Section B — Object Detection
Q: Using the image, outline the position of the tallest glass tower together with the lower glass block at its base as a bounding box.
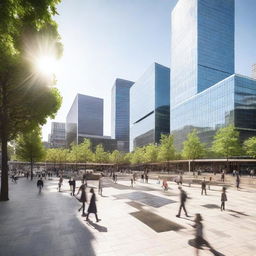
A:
[170,0,256,149]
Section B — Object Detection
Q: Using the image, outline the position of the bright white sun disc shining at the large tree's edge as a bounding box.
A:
[37,56,58,76]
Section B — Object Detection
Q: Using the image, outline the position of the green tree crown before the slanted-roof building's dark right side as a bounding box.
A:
[158,134,176,161]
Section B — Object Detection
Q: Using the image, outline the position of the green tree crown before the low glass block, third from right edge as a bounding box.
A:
[182,130,205,159]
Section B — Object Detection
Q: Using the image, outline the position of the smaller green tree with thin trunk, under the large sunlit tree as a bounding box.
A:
[16,127,46,180]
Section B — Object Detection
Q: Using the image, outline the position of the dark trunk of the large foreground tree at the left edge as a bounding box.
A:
[0,133,9,201]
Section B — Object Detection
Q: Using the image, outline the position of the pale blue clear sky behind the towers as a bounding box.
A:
[43,0,256,140]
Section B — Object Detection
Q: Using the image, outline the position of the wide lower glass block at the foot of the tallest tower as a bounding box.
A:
[171,75,256,149]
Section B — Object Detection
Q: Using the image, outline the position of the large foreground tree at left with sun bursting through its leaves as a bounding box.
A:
[0,0,62,201]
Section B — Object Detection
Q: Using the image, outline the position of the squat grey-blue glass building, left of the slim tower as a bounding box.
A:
[66,94,103,145]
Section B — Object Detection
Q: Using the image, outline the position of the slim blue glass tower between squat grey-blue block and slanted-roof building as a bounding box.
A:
[111,78,134,152]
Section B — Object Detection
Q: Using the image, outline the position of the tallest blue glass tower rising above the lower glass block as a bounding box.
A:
[171,0,234,107]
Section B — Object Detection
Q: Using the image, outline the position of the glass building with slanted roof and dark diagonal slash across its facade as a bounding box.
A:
[130,63,170,151]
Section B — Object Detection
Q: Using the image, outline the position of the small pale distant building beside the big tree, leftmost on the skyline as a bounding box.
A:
[48,122,66,148]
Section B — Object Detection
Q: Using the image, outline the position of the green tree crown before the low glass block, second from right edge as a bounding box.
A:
[212,125,242,158]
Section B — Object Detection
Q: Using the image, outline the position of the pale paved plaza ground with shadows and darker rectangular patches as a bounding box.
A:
[0,175,256,256]
